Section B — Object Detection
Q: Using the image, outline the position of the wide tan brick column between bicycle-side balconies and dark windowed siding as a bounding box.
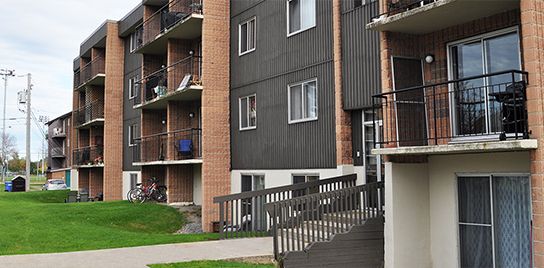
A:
[202,0,230,232]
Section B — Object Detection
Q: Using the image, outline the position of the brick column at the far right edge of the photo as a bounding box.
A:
[520,0,544,268]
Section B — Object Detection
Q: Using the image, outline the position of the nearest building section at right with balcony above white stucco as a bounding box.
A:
[366,0,544,267]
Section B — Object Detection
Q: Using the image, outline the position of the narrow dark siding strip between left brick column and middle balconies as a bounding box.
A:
[123,34,142,171]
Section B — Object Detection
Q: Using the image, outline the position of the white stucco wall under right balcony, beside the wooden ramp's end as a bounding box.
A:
[385,163,431,268]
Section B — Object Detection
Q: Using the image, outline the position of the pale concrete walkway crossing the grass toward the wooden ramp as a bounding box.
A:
[0,237,273,268]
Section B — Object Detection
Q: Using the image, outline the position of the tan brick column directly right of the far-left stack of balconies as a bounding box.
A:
[104,22,125,201]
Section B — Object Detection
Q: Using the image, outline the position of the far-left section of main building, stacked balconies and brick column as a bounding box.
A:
[72,20,124,200]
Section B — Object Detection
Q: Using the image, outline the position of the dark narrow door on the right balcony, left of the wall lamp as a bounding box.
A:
[393,57,427,146]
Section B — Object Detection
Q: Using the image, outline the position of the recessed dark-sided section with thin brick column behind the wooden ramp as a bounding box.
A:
[230,0,381,196]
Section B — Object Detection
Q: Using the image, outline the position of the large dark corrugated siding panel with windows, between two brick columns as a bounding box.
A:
[231,0,336,169]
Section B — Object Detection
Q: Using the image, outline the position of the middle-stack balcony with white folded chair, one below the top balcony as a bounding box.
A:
[133,56,202,110]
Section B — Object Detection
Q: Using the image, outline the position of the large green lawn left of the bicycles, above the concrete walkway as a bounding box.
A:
[0,188,219,255]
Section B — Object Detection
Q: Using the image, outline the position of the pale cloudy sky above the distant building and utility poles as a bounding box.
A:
[0,0,141,160]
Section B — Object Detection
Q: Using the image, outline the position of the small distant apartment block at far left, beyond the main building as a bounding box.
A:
[46,112,72,187]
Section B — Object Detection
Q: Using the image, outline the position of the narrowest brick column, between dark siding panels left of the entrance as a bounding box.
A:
[332,0,353,166]
